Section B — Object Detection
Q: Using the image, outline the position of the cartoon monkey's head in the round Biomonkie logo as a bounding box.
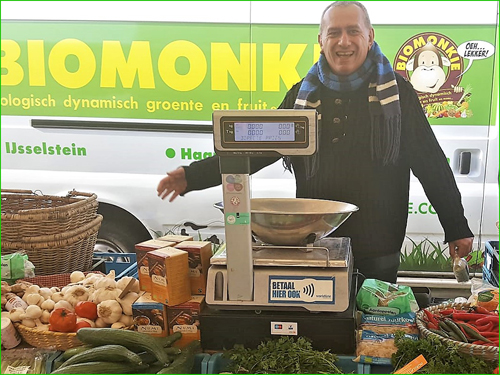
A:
[406,42,451,93]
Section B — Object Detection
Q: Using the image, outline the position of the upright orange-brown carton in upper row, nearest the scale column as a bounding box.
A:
[175,241,212,295]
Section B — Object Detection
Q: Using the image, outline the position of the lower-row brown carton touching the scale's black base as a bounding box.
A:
[167,296,205,348]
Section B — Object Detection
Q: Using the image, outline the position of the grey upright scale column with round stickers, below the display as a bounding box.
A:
[220,156,253,301]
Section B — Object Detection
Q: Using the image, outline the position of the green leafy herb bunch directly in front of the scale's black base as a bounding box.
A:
[224,336,343,374]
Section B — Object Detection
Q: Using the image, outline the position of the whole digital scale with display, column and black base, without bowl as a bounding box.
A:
[201,110,357,354]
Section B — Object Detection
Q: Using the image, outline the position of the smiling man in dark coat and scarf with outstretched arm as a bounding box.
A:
[157,1,473,283]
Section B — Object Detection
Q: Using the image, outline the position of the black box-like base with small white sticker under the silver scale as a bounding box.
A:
[200,276,358,355]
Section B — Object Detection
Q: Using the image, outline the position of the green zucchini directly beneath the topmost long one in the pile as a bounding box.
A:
[62,345,142,367]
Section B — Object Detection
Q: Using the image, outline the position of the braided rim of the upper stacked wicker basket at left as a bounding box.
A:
[1,189,97,221]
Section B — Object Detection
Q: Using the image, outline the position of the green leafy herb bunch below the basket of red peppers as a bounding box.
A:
[392,331,498,374]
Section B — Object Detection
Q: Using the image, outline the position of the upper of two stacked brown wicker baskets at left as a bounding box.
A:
[2,189,99,242]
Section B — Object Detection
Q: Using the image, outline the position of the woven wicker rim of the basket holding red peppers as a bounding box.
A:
[417,303,498,362]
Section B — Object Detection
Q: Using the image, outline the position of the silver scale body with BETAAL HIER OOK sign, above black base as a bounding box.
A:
[205,237,353,312]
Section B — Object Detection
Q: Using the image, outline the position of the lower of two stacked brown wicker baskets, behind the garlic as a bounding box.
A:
[2,215,103,275]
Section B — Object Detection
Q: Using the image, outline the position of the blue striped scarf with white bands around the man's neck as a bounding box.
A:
[294,42,401,179]
